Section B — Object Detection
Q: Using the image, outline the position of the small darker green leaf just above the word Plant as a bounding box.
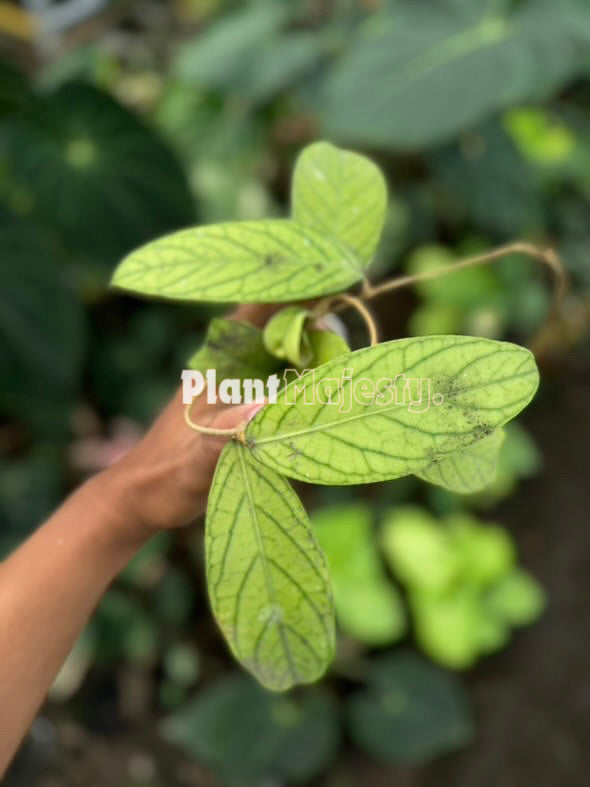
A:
[188,317,279,380]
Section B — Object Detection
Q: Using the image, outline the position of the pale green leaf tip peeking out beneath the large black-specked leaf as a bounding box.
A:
[416,429,505,495]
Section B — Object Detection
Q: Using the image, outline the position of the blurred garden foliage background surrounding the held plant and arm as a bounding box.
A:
[0,0,590,787]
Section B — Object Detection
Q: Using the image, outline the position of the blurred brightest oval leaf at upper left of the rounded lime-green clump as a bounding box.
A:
[381,506,461,592]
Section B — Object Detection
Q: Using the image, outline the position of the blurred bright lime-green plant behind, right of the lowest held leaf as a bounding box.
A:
[312,504,544,669]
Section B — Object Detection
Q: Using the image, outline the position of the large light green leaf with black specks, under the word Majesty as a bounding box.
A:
[247,336,539,485]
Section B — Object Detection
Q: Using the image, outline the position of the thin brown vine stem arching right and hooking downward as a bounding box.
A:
[361,241,568,315]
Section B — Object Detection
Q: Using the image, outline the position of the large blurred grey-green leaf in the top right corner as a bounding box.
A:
[317,0,590,150]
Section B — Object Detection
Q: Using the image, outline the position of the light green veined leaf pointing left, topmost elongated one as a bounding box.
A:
[113,219,361,303]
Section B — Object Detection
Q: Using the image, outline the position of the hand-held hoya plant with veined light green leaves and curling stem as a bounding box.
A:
[113,142,557,691]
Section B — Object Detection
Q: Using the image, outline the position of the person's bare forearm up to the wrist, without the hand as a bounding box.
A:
[0,471,148,776]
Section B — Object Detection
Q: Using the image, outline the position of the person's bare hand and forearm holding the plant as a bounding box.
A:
[0,306,271,777]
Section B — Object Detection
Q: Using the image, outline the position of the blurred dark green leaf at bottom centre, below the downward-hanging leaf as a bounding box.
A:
[163,675,340,787]
